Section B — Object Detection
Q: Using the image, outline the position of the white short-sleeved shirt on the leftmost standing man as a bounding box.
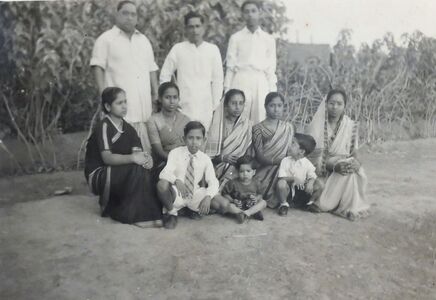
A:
[90,26,158,123]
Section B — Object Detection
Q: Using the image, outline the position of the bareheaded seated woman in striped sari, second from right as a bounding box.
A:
[253,92,294,208]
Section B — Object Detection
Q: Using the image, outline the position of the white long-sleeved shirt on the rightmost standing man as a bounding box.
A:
[224,27,277,91]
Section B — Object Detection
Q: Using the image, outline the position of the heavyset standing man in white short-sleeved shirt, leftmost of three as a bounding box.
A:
[90,0,158,150]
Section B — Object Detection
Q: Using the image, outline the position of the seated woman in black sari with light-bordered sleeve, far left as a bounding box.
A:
[85,87,162,224]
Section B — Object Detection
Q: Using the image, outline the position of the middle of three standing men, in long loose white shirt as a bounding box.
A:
[160,12,224,130]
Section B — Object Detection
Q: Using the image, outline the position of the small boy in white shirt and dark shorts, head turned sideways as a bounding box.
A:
[276,133,322,216]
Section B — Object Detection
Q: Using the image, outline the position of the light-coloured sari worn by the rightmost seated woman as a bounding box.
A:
[307,101,369,217]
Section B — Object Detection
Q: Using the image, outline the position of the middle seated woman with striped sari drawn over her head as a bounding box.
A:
[206,89,253,186]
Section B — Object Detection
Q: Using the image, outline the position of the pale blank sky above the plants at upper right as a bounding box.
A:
[282,0,436,47]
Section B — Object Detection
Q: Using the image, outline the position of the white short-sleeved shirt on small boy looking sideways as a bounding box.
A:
[278,156,317,185]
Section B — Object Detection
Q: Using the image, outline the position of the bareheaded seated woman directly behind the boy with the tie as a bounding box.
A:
[147,82,189,170]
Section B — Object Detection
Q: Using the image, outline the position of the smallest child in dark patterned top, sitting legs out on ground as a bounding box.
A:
[220,156,266,224]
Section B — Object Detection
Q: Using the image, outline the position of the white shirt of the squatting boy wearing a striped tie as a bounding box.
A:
[159,146,219,197]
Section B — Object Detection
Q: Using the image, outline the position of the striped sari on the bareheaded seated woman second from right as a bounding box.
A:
[253,121,294,208]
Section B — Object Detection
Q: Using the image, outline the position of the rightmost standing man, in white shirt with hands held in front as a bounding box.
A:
[224,0,277,124]
